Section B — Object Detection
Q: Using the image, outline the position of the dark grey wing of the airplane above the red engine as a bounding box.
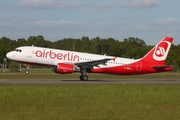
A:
[75,58,115,68]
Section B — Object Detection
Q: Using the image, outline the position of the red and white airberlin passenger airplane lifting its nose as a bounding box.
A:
[6,37,173,81]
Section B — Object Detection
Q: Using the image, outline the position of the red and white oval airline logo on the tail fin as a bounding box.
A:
[153,41,171,61]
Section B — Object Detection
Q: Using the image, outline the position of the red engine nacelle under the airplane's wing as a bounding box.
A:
[55,63,75,74]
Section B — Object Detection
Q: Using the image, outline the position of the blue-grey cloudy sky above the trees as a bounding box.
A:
[0,0,180,45]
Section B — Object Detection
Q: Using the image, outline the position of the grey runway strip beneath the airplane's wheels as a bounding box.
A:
[0,79,180,84]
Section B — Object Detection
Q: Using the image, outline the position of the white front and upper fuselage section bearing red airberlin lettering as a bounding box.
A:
[6,46,138,68]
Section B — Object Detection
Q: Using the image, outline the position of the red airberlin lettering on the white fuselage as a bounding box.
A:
[35,49,79,62]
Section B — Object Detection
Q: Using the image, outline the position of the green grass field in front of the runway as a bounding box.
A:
[0,84,180,120]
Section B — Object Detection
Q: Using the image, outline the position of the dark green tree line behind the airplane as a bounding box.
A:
[0,35,180,71]
